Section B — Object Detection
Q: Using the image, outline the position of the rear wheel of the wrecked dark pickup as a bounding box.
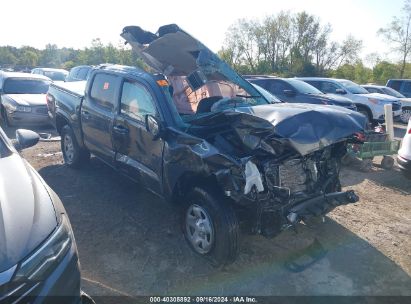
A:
[61,125,90,168]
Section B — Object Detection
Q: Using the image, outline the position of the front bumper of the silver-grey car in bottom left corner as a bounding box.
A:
[0,244,81,304]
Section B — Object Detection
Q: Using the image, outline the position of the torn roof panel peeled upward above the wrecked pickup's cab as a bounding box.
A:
[121,24,259,95]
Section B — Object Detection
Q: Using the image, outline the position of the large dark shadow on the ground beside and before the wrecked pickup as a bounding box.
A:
[40,158,411,302]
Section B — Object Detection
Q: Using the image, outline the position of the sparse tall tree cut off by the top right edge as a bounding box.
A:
[377,0,411,78]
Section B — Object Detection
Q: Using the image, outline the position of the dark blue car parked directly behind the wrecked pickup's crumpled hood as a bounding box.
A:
[244,75,357,111]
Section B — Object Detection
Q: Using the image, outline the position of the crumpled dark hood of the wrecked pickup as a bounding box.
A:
[190,103,365,155]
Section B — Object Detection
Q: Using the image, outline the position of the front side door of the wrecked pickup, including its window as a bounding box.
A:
[113,79,164,193]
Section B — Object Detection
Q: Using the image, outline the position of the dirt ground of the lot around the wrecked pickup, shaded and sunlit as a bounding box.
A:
[9,123,411,296]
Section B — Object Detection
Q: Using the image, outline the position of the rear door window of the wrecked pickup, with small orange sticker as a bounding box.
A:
[90,73,118,109]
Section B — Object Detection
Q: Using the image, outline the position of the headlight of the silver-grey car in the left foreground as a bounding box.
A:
[13,214,73,282]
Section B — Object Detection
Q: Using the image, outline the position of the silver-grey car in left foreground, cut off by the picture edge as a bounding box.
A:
[0,128,92,303]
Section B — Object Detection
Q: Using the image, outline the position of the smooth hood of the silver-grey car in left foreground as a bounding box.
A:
[0,154,57,273]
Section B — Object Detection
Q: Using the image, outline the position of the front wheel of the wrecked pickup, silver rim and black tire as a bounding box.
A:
[181,187,240,267]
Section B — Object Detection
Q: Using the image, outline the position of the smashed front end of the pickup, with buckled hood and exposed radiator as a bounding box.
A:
[185,106,363,236]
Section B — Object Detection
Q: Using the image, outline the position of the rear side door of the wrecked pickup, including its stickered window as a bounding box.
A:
[80,71,121,163]
